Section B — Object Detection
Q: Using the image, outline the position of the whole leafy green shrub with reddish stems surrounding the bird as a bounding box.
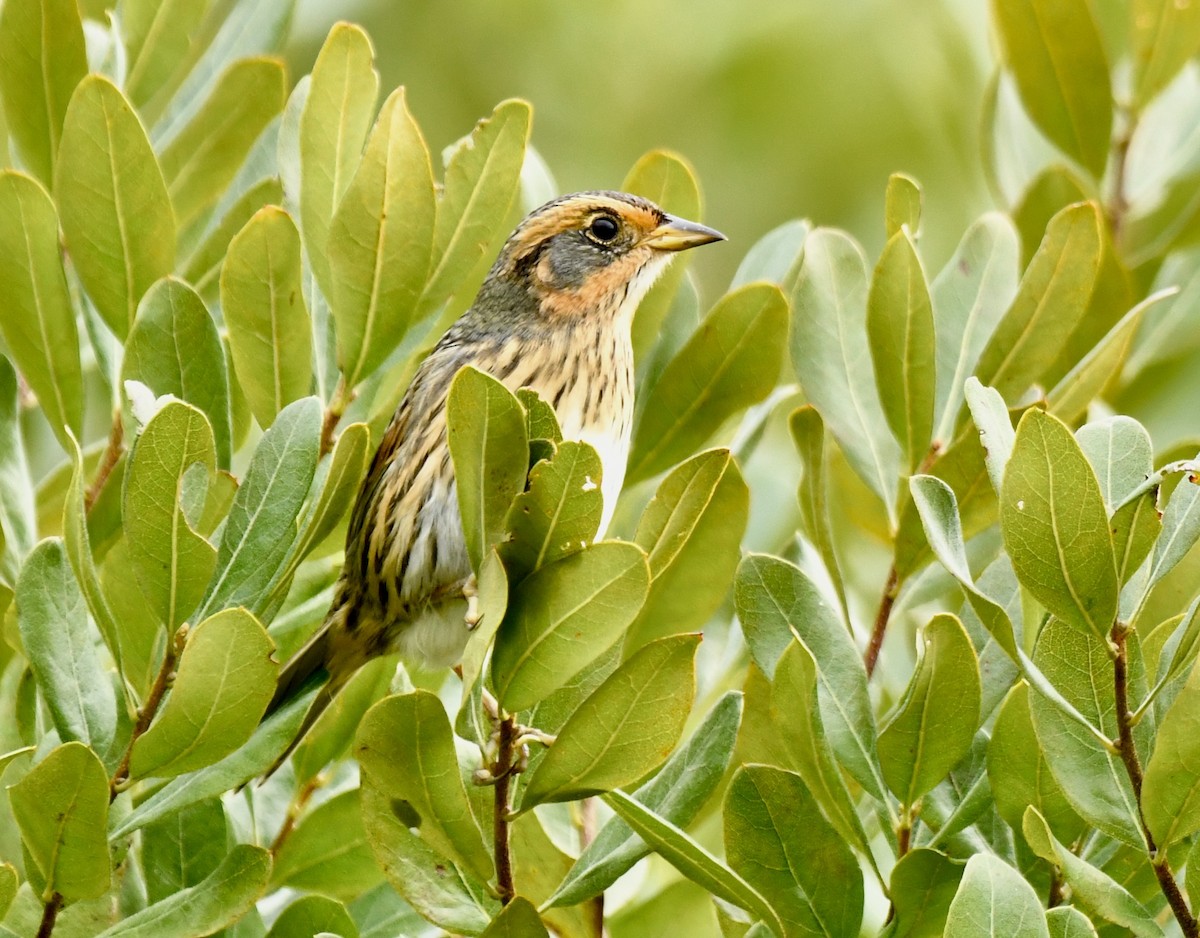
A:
[0,0,1200,938]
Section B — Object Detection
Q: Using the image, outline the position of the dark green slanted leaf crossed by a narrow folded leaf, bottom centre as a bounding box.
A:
[546,691,742,906]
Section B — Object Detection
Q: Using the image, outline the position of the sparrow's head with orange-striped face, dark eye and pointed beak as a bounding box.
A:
[480,192,725,321]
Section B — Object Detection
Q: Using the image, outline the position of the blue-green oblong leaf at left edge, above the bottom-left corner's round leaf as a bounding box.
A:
[17,537,116,753]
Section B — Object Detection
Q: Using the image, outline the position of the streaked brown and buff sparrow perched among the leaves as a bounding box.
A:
[266,190,725,771]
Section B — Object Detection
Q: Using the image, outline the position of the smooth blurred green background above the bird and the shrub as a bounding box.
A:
[288,0,992,297]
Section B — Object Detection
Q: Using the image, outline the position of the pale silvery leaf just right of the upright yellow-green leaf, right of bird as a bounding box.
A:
[930,212,1020,440]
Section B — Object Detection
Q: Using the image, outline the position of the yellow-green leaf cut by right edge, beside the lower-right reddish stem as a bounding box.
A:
[1141,667,1200,850]
